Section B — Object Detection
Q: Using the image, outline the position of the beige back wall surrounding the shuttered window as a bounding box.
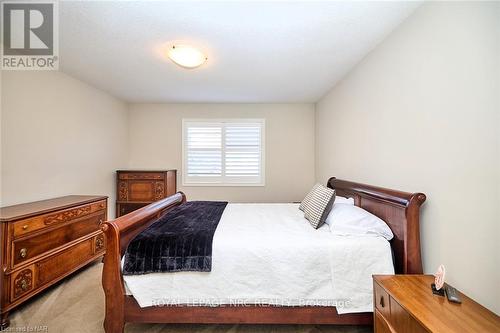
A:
[129,104,315,202]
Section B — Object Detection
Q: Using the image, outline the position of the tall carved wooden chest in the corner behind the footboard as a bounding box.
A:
[116,170,177,217]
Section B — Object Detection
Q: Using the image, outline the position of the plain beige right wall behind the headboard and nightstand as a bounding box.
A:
[316,2,500,313]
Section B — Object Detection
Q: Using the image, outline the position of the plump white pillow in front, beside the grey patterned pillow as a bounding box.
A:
[325,203,394,240]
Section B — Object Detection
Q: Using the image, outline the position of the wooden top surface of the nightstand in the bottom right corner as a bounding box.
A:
[374,275,500,333]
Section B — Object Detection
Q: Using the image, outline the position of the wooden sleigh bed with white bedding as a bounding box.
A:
[103,178,425,332]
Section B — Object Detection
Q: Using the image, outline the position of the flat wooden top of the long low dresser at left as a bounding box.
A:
[0,195,108,222]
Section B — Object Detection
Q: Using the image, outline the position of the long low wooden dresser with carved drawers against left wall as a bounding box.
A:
[0,195,107,329]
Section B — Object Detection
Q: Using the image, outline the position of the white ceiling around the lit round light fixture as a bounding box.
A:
[59,1,420,103]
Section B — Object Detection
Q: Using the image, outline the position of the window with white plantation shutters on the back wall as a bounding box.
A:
[182,119,265,186]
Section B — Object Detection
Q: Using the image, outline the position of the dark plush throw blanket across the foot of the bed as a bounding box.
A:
[123,201,227,275]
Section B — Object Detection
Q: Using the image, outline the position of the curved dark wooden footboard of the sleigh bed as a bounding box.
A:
[102,192,186,333]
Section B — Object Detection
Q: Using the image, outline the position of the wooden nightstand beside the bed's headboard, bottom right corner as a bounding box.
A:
[373,275,500,333]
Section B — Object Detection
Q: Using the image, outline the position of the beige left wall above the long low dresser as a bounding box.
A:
[1,71,128,216]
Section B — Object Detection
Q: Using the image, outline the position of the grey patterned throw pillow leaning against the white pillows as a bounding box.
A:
[304,185,335,229]
